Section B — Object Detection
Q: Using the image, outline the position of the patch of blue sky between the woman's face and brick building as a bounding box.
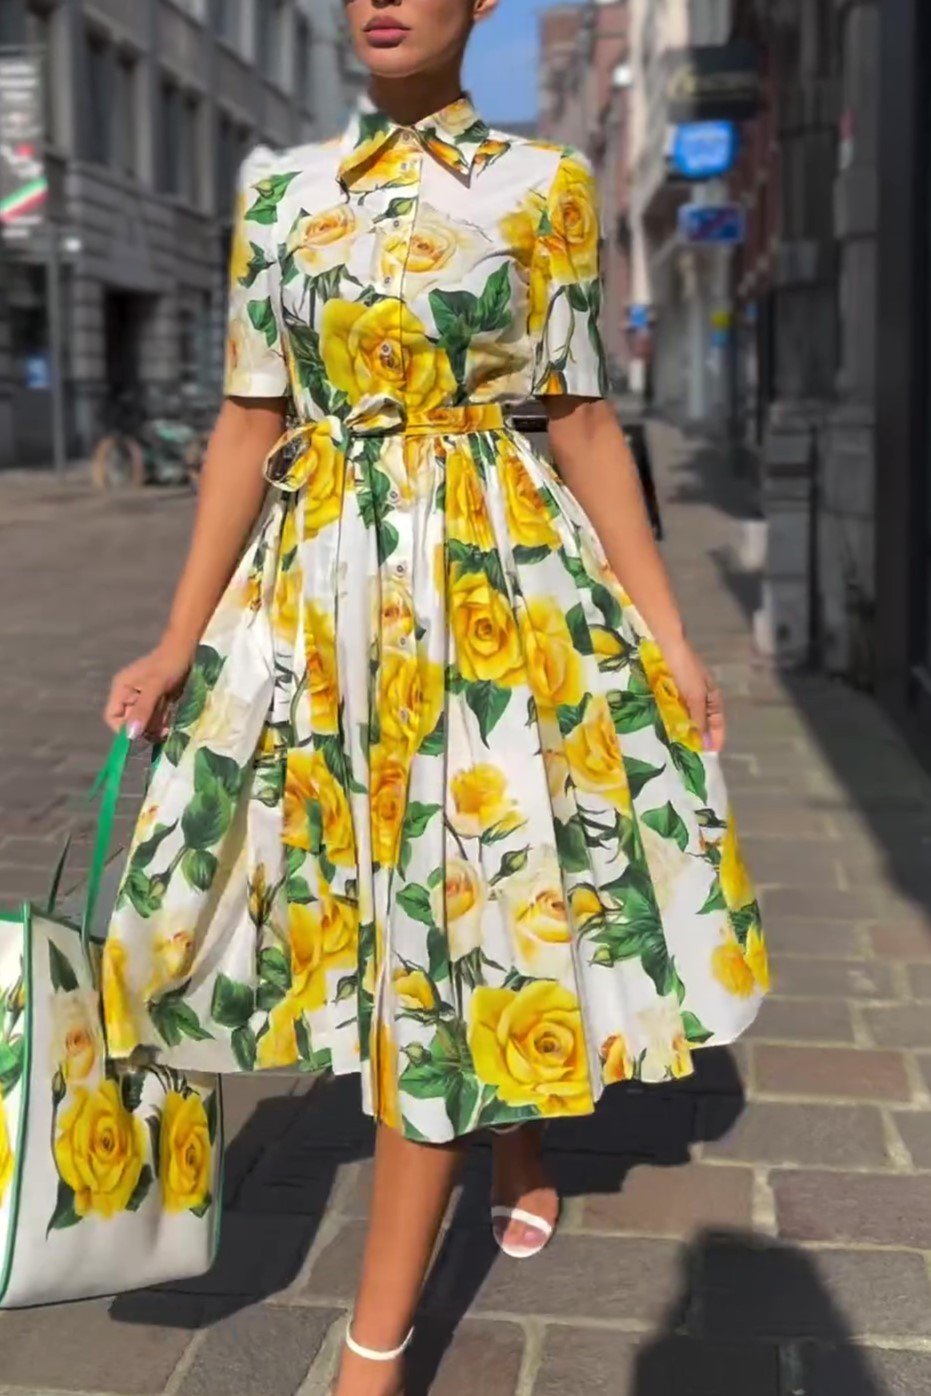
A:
[466,0,575,123]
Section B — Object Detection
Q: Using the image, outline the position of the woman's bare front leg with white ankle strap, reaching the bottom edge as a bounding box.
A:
[335,1125,462,1396]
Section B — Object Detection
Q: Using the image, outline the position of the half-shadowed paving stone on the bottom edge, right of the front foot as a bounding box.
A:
[533,1326,780,1396]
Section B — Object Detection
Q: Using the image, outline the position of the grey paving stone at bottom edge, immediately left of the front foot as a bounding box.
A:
[177,1304,341,1396]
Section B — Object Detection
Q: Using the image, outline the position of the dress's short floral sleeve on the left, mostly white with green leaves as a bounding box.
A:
[223,147,290,398]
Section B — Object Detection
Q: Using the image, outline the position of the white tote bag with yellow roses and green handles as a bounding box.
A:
[0,734,222,1308]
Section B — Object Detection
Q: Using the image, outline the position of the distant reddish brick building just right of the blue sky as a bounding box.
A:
[540,0,631,384]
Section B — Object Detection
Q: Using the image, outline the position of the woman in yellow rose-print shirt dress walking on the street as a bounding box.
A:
[105,0,766,1396]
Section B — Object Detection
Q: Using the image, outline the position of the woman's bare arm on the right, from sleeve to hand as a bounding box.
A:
[543,395,724,751]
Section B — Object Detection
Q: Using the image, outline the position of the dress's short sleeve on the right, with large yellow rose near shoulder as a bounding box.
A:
[530,151,607,398]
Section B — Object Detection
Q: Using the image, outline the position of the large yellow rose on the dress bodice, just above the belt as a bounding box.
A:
[321,299,456,412]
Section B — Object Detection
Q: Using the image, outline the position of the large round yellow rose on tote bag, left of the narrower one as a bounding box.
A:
[54,1081,147,1217]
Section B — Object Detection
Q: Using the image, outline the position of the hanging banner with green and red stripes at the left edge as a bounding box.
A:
[0,53,49,242]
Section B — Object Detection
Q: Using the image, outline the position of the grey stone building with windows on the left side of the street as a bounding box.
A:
[0,0,359,465]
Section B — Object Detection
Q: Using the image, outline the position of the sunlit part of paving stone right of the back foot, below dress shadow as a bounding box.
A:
[582,1163,754,1237]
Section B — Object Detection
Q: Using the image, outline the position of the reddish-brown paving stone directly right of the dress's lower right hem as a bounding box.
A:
[754,1043,911,1100]
